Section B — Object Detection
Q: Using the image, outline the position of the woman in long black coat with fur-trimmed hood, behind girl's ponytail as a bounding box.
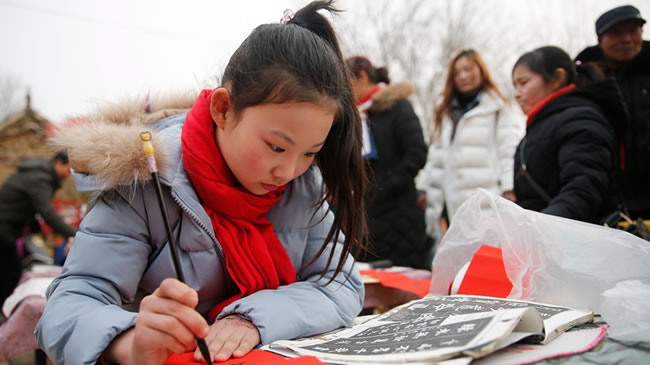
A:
[346,56,432,270]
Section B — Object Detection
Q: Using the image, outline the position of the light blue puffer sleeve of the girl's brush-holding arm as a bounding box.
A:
[35,189,151,364]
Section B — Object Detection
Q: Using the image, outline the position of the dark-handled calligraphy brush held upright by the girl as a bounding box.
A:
[140,132,212,364]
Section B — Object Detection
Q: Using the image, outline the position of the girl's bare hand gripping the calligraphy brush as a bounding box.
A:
[125,279,210,365]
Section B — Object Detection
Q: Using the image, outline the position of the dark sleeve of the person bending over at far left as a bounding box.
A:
[25,178,75,238]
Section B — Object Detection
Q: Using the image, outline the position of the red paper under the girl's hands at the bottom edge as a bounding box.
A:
[165,350,324,365]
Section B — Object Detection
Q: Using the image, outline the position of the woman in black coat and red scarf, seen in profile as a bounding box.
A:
[512,47,624,223]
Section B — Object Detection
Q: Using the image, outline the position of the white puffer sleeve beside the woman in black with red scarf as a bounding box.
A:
[496,104,526,193]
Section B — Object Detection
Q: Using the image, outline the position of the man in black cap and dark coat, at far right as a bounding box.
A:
[576,5,650,219]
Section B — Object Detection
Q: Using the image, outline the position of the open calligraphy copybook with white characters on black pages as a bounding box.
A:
[266,295,593,364]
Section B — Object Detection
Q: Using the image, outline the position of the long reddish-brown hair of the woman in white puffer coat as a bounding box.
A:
[430,49,510,142]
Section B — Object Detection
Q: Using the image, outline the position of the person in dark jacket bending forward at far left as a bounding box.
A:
[0,152,75,303]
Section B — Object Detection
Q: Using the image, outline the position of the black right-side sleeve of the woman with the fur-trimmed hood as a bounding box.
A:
[387,99,427,190]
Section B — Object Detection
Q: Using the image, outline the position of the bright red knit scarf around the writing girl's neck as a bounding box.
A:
[181,90,296,321]
